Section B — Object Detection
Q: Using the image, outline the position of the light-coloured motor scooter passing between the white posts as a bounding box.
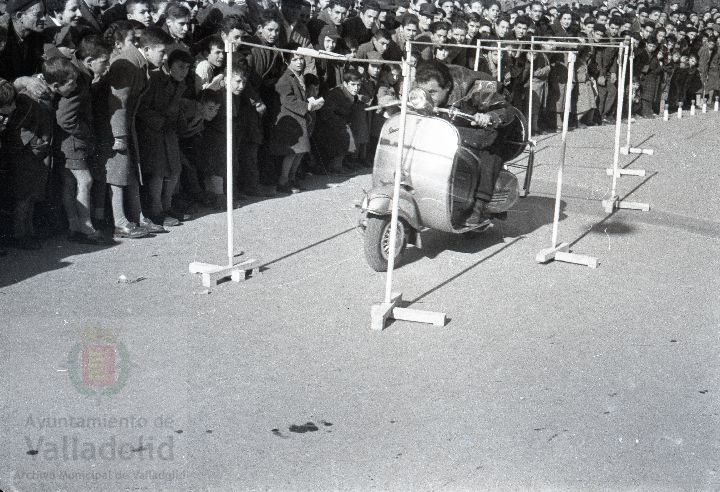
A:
[359,91,529,272]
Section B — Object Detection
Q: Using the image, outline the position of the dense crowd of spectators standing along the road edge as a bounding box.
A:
[0,0,720,249]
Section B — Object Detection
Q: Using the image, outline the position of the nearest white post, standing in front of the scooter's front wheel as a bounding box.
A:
[370,41,447,330]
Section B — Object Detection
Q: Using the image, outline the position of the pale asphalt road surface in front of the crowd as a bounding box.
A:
[0,112,720,492]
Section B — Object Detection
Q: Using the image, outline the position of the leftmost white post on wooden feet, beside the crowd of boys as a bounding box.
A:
[189,41,260,287]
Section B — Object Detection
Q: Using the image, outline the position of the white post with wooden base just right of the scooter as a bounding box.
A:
[535,53,598,268]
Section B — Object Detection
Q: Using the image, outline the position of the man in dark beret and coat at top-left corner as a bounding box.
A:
[0,0,49,100]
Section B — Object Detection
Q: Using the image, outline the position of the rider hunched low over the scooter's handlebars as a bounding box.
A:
[415,60,514,226]
